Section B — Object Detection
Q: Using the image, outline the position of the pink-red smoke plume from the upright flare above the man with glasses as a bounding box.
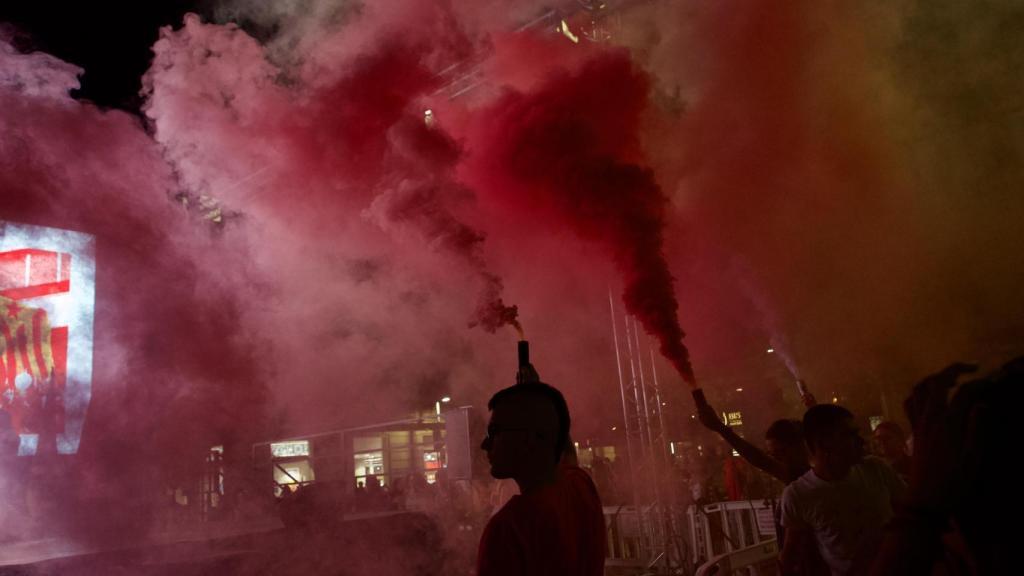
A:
[146,16,516,332]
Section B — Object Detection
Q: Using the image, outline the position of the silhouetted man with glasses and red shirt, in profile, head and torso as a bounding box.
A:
[477,382,605,576]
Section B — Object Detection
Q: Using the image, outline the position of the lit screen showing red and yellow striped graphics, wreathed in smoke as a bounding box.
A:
[0,220,96,456]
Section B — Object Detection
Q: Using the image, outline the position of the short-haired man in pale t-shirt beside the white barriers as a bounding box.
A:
[780,404,906,576]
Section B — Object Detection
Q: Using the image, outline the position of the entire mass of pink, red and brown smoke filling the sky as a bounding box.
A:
[0,0,1024,573]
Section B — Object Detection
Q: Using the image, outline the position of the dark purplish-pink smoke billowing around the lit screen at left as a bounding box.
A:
[0,33,266,538]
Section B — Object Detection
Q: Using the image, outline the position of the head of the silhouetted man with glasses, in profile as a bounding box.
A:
[480,382,570,494]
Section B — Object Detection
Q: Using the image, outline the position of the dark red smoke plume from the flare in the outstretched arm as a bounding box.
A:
[467,47,695,384]
